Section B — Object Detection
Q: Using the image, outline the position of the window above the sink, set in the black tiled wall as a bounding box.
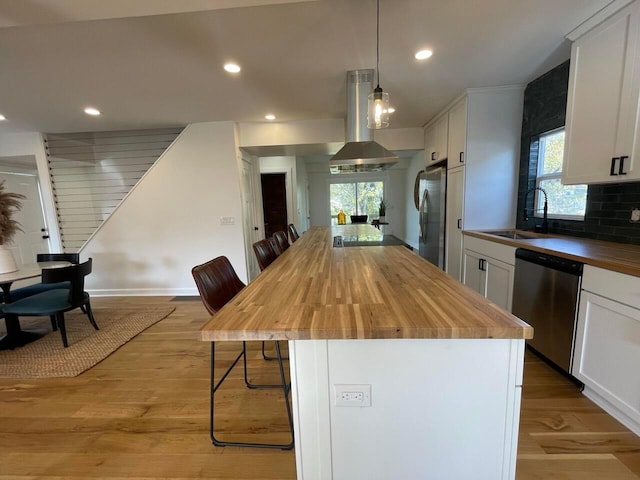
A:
[531,128,587,220]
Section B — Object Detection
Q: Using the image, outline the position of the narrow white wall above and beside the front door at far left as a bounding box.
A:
[0,132,62,252]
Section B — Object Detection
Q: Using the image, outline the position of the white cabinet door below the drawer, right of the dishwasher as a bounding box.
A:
[571,290,640,432]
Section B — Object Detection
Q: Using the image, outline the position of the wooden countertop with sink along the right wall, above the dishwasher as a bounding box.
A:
[464,231,640,277]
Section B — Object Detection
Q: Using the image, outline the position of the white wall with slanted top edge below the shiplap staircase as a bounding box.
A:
[81,122,247,295]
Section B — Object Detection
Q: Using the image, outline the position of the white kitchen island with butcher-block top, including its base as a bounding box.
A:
[202,225,533,480]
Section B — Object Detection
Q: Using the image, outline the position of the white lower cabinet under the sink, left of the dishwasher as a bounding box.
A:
[462,236,515,311]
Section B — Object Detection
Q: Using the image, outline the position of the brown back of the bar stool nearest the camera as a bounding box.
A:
[191,257,245,315]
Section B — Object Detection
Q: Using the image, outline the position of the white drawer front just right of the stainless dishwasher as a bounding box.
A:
[582,265,640,308]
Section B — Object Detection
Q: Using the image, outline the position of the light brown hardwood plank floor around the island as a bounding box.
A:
[0,297,640,480]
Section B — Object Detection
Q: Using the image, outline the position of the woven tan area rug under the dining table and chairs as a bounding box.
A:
[0,307,175,378]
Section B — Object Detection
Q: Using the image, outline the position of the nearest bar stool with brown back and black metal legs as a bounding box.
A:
[191,257,294,450]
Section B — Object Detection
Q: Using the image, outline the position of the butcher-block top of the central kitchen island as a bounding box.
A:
[201,224,533,341]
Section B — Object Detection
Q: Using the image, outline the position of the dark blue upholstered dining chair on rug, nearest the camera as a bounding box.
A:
[2,259,99,348]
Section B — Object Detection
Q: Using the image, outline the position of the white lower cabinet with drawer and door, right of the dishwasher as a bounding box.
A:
[572,265,640,435]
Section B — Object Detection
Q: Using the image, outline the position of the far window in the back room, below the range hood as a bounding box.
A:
[329,182,384,225]
